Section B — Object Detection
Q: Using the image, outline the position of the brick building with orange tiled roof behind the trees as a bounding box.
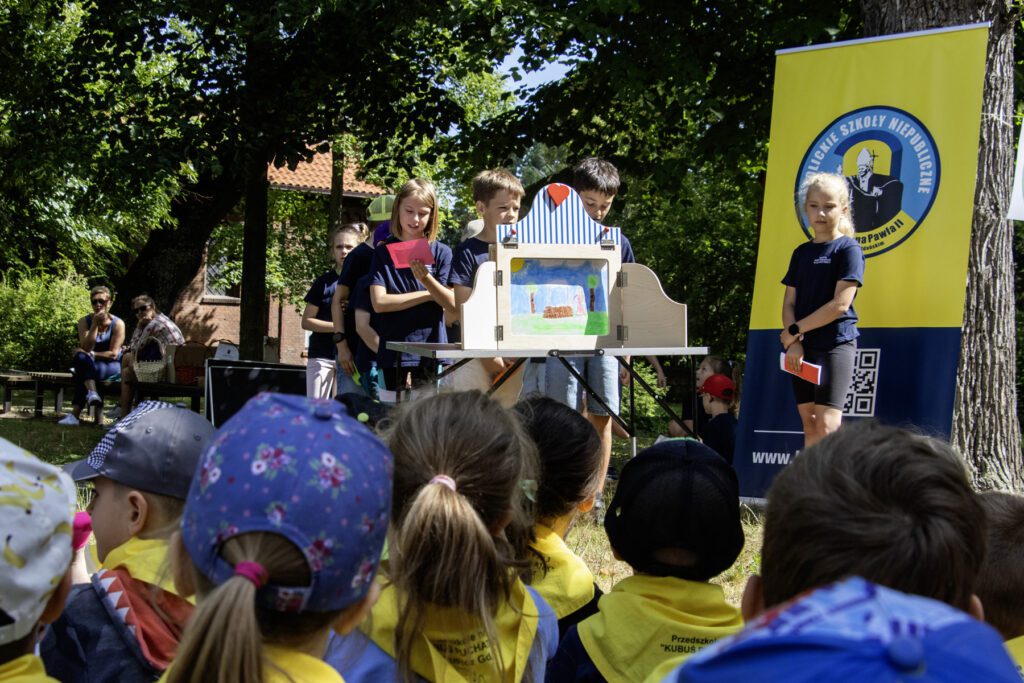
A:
[171,154,388,365]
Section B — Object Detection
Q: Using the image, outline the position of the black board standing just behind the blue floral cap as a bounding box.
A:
[206,358,306,427]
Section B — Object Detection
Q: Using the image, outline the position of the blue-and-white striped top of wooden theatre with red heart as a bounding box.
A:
[498,183,621,245]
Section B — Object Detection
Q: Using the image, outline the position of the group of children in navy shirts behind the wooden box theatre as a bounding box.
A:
[303,158,704,465]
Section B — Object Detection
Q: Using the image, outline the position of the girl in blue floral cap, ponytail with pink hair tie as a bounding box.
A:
[161,394,392,683]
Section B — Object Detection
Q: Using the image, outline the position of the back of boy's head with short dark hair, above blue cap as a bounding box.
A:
[751,422,985,615]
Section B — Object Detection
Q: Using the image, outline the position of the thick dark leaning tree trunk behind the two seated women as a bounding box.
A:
[114,174,242,321]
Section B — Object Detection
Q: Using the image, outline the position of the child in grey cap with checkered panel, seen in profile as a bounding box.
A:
[40,401,216,683]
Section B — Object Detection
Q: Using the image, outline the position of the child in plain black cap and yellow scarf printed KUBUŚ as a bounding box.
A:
[547,439,743,682]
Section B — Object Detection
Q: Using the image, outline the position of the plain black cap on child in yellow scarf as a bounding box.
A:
[604,438,744,581]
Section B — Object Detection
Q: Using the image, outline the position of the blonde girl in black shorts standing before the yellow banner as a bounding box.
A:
[779,173,864,447]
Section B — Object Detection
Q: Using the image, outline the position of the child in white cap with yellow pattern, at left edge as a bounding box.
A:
[0,438,75,683]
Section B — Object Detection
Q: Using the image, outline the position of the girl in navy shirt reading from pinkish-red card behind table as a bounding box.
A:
[370,178,455,391]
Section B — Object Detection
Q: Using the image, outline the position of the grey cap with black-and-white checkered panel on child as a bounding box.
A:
[65,400,215,500]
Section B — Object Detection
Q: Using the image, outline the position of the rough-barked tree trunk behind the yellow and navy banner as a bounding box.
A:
[861,0,1024,490]
